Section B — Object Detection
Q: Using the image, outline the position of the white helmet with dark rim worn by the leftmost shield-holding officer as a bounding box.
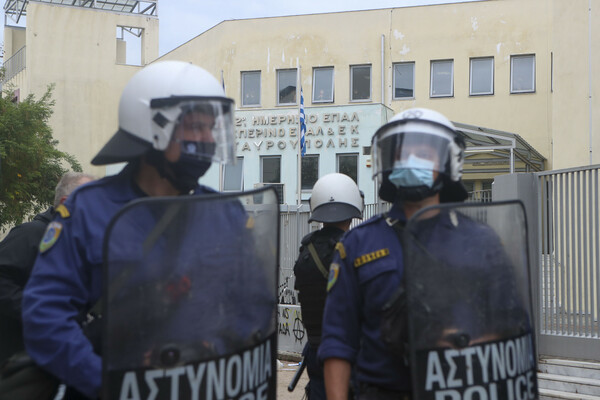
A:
[92,61,235,165]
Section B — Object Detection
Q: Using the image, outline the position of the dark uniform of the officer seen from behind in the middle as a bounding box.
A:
[294,226,344,399]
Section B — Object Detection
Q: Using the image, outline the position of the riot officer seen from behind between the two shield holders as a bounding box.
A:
[294,173,363,400]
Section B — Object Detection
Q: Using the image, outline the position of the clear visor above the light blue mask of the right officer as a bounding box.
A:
[373,127,451,180]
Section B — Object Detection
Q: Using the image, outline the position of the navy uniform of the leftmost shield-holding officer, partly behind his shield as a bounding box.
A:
[23,166,274,398]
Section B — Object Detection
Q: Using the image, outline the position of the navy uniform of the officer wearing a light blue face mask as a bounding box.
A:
[319,203,518,399]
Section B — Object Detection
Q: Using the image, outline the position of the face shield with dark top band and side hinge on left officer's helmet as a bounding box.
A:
[151,98,235,164]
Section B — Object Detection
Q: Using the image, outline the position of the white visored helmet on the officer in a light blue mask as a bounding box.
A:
[372,108,467,201]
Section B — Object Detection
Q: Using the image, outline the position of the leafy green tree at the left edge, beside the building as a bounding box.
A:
[0,85,81,226]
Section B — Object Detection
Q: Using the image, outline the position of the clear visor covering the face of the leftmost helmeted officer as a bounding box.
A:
[171,98,235,163]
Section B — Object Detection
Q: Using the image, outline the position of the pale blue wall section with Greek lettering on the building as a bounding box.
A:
[232,103,392,204]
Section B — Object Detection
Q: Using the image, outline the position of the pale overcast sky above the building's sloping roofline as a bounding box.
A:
[0,0,481,59]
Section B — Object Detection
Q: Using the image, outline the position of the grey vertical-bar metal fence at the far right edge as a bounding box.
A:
[536,166,600,360]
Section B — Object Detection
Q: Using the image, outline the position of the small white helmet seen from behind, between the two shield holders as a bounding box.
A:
[308,173,364,222]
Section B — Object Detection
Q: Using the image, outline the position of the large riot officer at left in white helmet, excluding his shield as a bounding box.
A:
[23,61,239,398]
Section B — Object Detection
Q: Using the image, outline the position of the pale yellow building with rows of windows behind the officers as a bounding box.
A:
[4,0,600,204]
